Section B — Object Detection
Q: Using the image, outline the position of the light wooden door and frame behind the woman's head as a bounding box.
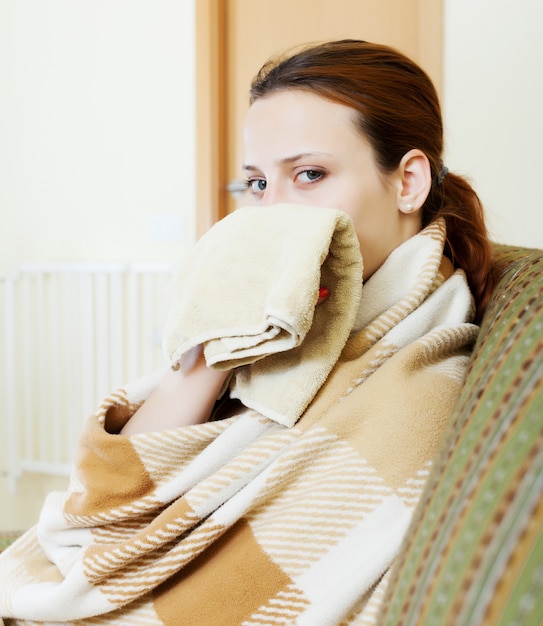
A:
[195,0,442,235]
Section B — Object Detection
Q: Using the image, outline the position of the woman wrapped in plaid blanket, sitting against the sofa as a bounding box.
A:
[0,40,493,626]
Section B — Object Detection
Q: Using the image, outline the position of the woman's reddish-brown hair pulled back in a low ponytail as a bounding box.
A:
[250,39,495,320]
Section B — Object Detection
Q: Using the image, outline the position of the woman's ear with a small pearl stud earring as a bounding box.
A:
[398,148,432,214]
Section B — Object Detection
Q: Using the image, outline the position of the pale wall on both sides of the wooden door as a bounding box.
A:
[0,0,543,274]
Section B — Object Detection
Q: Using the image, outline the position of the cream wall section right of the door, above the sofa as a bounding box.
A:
[443,0,543,248]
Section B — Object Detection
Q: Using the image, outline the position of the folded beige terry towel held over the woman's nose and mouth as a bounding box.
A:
[164,204,362,426]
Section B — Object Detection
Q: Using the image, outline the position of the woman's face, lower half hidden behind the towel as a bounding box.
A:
[243,90,420,279]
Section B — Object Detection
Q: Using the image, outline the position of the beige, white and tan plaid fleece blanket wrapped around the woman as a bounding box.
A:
[0,207,477,626]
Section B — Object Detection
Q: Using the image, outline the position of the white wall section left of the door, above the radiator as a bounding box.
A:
[0,0,195,275]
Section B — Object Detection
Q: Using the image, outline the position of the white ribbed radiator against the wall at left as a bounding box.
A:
[5,264,173,488]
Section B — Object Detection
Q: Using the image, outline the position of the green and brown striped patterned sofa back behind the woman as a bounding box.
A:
[380,246,543,626]
